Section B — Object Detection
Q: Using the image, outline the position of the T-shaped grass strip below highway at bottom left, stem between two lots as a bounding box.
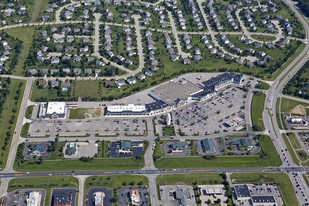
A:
[8,177,78,206]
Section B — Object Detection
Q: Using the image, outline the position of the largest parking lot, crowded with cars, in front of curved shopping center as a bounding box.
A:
[172,85,250,135]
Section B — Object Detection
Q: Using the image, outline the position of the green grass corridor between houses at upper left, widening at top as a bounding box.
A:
[5,26,34,76]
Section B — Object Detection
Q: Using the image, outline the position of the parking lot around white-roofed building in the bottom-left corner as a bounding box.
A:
[2,189,45,206]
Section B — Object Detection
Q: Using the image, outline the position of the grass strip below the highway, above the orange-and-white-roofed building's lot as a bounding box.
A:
[85,175,148,190]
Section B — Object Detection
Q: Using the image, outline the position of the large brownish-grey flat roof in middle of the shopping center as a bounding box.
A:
[150,80,203,105]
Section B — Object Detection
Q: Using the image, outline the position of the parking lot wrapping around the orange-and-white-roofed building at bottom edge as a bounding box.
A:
[117,187,149,206]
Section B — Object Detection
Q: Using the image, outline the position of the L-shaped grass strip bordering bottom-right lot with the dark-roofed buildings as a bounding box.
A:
[231,173,299,206]
